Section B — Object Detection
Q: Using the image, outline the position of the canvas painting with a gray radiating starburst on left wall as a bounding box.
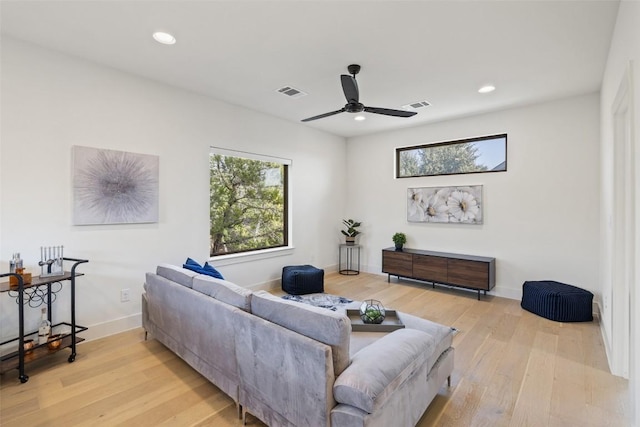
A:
[72,146,160,225]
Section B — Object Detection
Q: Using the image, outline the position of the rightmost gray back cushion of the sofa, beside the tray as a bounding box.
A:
[251,291,351,376]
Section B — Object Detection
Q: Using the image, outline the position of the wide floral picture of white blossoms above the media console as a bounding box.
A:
[407,185,482,224]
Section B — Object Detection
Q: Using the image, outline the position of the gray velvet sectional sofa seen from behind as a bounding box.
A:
[142,265,454,427]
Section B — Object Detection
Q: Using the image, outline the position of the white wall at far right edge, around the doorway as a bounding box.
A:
[600,1,640,426]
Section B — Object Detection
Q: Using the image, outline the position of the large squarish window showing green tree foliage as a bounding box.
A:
[209,148,291,256]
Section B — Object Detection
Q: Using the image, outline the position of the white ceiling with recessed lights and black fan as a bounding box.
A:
[0,0,618,137]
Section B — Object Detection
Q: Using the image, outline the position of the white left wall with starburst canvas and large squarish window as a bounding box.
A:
[0,37,346,338]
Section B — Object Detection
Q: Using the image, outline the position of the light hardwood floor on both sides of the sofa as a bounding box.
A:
[0,273,630,427]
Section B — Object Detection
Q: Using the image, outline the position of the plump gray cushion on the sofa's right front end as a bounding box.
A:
[333,329,435,414]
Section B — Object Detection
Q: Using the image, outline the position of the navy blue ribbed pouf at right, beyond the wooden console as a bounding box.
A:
[520,280,593,322]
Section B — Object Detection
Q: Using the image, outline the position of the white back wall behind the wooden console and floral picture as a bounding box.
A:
[347,94,600,299]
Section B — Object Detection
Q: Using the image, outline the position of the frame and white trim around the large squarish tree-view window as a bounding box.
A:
[208,146,293,265]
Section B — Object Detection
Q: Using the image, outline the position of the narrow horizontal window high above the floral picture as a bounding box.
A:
[396,134,507,178]
